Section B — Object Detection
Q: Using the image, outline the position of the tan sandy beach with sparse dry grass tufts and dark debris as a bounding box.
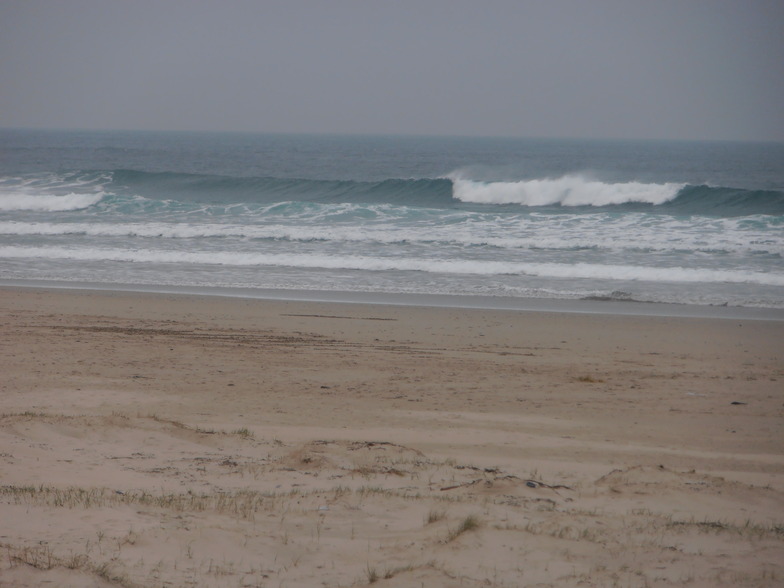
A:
[0,288,784,587]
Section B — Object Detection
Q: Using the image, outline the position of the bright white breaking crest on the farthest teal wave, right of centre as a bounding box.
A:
[450,175,685,206]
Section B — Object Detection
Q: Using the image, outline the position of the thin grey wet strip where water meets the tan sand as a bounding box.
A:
[0,279,784,321]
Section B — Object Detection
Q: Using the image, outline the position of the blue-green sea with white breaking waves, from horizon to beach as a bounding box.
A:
[0,129,784,309]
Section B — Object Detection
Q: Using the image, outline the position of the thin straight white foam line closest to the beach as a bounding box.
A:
[0,246,784,286]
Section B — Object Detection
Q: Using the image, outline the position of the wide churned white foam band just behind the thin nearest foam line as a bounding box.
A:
[0,213,784,255]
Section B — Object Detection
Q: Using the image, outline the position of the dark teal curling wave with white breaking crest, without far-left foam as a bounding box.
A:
[96,170,784,216]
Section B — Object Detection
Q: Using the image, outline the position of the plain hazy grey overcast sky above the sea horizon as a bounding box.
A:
[0,0,784,141]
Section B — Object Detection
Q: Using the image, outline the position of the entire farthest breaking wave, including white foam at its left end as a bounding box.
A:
[0,169,784,216]
